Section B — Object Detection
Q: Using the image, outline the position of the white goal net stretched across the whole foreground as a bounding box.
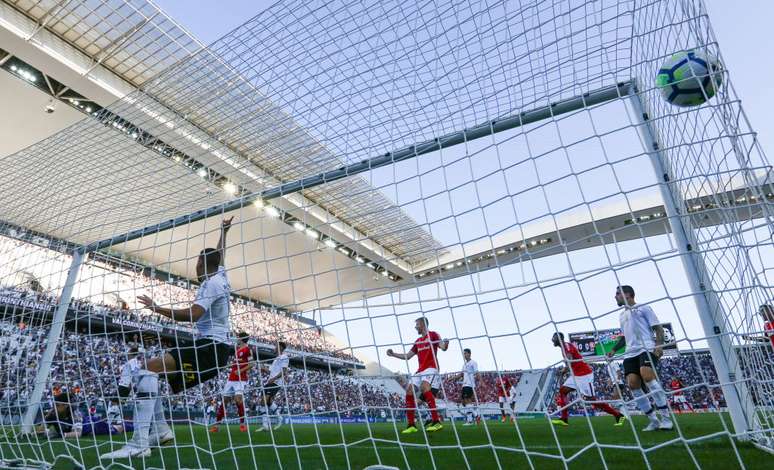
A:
[0,0,774,468]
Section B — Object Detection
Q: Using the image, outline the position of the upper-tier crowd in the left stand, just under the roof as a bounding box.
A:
[0,236,358,362]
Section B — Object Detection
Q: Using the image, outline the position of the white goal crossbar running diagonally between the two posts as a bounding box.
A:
[80,81,631,253]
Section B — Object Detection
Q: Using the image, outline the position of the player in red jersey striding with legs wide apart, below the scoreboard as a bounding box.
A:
[551,332,626,426]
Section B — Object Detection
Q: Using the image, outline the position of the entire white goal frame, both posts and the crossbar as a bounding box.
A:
[22,76,769,444]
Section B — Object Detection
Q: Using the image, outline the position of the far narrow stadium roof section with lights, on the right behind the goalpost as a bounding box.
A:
[415,170,774,283]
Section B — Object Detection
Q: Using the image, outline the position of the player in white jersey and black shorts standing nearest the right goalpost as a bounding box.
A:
[607,286,674,431]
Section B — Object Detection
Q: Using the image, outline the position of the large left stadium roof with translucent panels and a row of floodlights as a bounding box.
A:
[0,0,442,307]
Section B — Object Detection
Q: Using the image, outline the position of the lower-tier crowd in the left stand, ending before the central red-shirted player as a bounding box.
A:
[0,322,403,414]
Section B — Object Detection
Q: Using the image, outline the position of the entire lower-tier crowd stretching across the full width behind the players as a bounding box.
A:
[0,321,772,424]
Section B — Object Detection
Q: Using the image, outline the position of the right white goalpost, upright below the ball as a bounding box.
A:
[629,85,755,440]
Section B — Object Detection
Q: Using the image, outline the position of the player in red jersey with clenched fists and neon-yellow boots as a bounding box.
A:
[387,317,449,434]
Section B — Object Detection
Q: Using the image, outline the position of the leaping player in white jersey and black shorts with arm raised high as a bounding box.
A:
[100,217,234,459]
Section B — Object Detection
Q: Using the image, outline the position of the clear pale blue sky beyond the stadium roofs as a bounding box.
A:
[152,0,774,371]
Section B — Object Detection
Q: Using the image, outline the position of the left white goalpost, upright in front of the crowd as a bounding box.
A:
[21,250,84,434]
